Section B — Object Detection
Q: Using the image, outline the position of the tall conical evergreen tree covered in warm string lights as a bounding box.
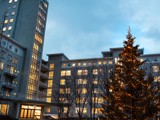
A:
[103,29,158,120]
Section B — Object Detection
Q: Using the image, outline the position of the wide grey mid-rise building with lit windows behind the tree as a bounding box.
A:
[47,48,160,118]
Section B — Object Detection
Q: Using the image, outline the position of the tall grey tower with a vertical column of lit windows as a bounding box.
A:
[0,0,48,99]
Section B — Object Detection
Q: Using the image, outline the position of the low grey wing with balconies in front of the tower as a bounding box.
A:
[0,33,26,118]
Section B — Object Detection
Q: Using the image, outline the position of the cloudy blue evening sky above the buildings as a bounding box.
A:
[43,0,160,60]
